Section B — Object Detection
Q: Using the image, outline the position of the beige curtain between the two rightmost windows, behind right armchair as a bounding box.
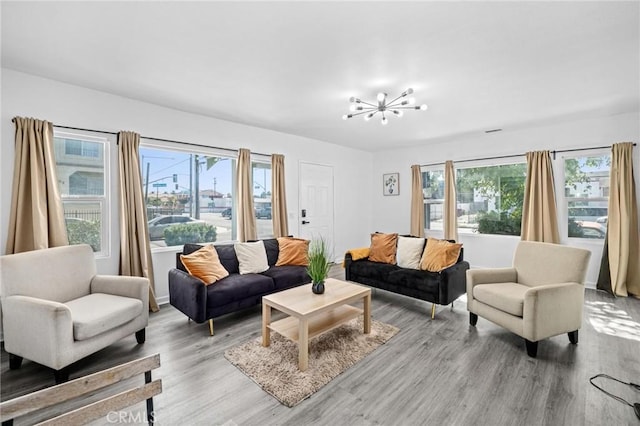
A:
[520,151,560,244]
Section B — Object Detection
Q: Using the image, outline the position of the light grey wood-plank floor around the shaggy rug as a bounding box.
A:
[0,266,640,426]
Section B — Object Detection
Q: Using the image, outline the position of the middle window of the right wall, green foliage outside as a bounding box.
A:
[456,163,527,235]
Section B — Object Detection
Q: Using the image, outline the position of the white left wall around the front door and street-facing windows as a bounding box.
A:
[0,69,373,302]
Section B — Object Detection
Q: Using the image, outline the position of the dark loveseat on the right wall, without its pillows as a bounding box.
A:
[344,241,469,318]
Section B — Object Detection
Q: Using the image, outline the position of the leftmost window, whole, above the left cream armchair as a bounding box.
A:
[53,132,109,255]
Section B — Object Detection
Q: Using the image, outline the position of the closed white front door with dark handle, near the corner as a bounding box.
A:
[298,162,334,258]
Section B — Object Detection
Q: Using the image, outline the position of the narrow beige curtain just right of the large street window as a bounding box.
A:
[236,148,258,241]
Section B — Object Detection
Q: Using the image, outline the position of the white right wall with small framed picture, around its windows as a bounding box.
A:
[373,111,640,286]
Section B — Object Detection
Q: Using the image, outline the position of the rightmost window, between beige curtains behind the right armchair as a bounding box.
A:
[564,154,611,239]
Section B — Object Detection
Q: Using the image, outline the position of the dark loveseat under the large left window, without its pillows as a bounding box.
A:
[169,238,311,335]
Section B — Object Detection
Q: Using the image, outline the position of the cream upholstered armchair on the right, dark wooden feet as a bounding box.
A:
[467,241,591,358]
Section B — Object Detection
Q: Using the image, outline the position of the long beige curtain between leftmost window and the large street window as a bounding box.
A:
[118,132,159,312]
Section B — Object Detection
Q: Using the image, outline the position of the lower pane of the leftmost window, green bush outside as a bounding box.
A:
[62,201,102,252]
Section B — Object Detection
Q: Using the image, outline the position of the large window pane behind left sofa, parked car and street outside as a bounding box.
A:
[140,146,235,248]
